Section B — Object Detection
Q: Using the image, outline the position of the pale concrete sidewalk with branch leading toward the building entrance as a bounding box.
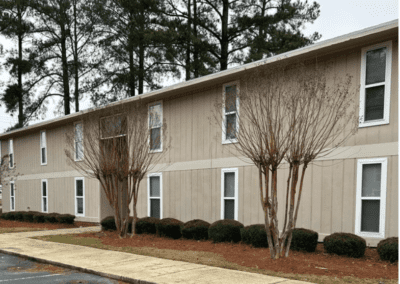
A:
[0,227,308,284]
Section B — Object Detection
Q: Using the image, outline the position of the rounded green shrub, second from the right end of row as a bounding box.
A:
[324,233,367,258]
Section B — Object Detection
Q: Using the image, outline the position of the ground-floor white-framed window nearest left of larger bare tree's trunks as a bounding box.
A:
[221,168,238,221]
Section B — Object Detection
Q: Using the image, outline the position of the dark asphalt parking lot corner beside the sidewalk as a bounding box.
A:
[0,253,126,284]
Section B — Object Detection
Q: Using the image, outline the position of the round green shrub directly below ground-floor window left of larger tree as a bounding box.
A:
[208,220,244,243]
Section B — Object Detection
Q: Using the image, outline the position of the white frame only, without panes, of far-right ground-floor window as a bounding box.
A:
[355,158,387,238]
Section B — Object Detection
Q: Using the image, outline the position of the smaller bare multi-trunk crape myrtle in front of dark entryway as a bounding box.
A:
[65,99,168,238]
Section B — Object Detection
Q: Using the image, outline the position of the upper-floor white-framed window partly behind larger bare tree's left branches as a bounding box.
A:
[222,82,239,144]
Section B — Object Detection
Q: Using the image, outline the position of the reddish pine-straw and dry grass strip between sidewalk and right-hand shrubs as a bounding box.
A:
[35,232,398,284]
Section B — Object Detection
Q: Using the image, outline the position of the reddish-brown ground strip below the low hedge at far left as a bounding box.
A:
[0,219,97,234]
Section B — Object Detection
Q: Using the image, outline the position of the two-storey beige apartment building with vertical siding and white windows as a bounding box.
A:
[0,20,399,246]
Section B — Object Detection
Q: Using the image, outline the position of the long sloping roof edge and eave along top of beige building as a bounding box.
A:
[0,20,398,139]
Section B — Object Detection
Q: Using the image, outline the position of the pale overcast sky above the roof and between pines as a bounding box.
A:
[0,0,399,133]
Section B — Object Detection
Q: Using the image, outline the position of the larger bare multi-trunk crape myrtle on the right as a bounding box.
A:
[213,64,359,259]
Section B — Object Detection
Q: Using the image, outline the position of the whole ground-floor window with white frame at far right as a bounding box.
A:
[355,158,387,238]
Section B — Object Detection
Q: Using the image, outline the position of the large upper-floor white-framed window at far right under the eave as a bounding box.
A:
[359,41,392,127]
